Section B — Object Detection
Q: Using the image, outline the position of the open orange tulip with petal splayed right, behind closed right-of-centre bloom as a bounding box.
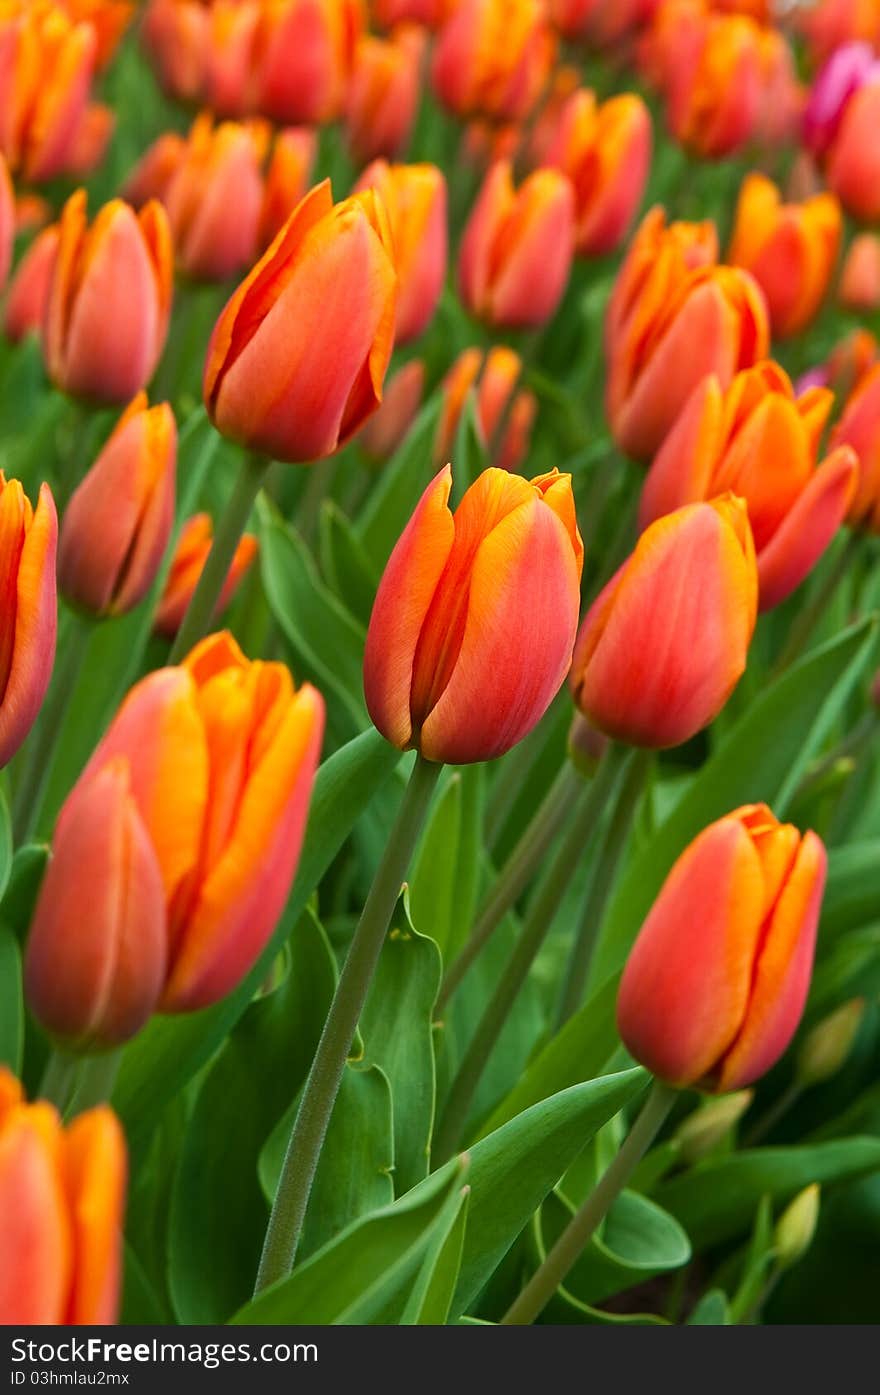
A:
[639,363,858,610]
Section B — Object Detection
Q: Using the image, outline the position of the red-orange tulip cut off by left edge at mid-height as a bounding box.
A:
[0,470,59,769]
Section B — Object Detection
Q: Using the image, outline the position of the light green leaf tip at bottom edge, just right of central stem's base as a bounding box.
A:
[232,1159,466,1325]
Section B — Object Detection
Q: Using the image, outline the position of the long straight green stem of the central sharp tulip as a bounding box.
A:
[255,756,442,1293]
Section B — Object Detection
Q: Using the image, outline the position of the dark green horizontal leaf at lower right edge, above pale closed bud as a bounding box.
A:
[654,1137,880,1250]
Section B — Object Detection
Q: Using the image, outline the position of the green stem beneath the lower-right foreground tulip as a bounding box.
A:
[501,1080,678,1327]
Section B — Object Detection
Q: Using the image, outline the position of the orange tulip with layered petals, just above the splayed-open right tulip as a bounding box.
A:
[605,209,770,460]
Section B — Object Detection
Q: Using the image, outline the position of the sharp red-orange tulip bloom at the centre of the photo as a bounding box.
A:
[364,466,583,764]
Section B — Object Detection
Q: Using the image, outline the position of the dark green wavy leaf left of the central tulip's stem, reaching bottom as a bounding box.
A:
[169,911,336,1322]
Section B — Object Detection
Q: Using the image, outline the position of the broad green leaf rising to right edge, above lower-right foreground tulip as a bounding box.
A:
[591,618,877,983]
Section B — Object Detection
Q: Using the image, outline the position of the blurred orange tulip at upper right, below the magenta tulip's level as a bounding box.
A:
[728,174,844,339]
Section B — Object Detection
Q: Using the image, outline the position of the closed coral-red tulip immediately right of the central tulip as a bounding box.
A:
[570,495,757,749]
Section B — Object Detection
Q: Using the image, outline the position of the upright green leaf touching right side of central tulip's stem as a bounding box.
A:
[360,894,441,1196]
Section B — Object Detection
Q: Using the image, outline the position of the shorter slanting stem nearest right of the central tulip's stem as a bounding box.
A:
[437,759,583,1011]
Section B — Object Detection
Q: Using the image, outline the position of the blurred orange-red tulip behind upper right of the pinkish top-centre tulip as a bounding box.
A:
[544,88,651,257]
